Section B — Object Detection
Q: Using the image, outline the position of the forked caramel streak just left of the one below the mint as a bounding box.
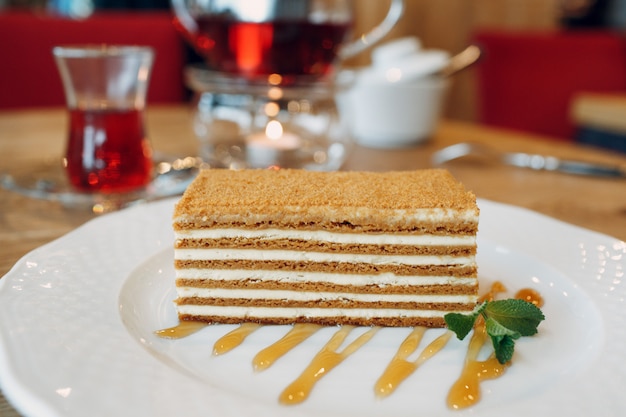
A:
[374,327,452,397]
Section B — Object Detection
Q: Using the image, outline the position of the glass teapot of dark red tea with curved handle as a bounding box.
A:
[172,0,404,80]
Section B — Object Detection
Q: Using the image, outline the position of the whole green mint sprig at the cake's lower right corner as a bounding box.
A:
[444,299,545,364]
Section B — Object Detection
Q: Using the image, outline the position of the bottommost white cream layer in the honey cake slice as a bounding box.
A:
[178,305,471,319]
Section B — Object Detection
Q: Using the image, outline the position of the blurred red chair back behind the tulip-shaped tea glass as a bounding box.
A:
[0,11,185,109]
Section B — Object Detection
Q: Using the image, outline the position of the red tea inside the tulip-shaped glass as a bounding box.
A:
[66,109,152,192]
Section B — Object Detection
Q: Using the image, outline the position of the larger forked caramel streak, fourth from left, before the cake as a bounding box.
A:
[279,326,379,405]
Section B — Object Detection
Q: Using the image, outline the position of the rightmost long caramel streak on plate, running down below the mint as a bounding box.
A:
[447,324,507,410]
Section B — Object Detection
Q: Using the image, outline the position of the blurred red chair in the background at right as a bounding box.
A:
[475,31,626,141]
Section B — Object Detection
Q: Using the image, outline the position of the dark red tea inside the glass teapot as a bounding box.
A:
[192,15,351,77]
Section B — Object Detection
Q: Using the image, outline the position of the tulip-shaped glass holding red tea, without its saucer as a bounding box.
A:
[53,46,154,193]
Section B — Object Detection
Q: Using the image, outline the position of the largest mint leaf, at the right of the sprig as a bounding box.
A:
[484,299,545,336]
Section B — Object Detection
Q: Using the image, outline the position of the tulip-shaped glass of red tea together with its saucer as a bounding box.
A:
[0,45,197,214]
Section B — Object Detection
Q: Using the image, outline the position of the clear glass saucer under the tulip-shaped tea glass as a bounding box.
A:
[0,156,203,214]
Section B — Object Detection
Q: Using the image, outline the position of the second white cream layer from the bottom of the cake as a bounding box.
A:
[176,287,476,304]
